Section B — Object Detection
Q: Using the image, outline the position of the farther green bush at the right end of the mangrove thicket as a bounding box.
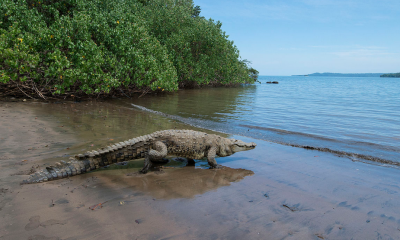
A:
[144,0,254,86]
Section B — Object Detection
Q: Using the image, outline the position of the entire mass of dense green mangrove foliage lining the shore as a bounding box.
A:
[0,0,254,94]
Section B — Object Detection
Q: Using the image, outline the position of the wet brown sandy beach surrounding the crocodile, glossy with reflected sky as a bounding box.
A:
[0,102,400,240]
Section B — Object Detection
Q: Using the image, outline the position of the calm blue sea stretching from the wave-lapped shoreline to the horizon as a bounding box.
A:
[114,76,400,165]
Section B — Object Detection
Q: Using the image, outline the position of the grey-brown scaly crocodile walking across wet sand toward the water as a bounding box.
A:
[21,130,256,184]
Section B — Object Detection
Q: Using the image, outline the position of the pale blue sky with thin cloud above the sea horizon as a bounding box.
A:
[194,0,400,75]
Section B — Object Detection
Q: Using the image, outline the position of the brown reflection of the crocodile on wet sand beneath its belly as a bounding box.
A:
[97,166,254,199]
